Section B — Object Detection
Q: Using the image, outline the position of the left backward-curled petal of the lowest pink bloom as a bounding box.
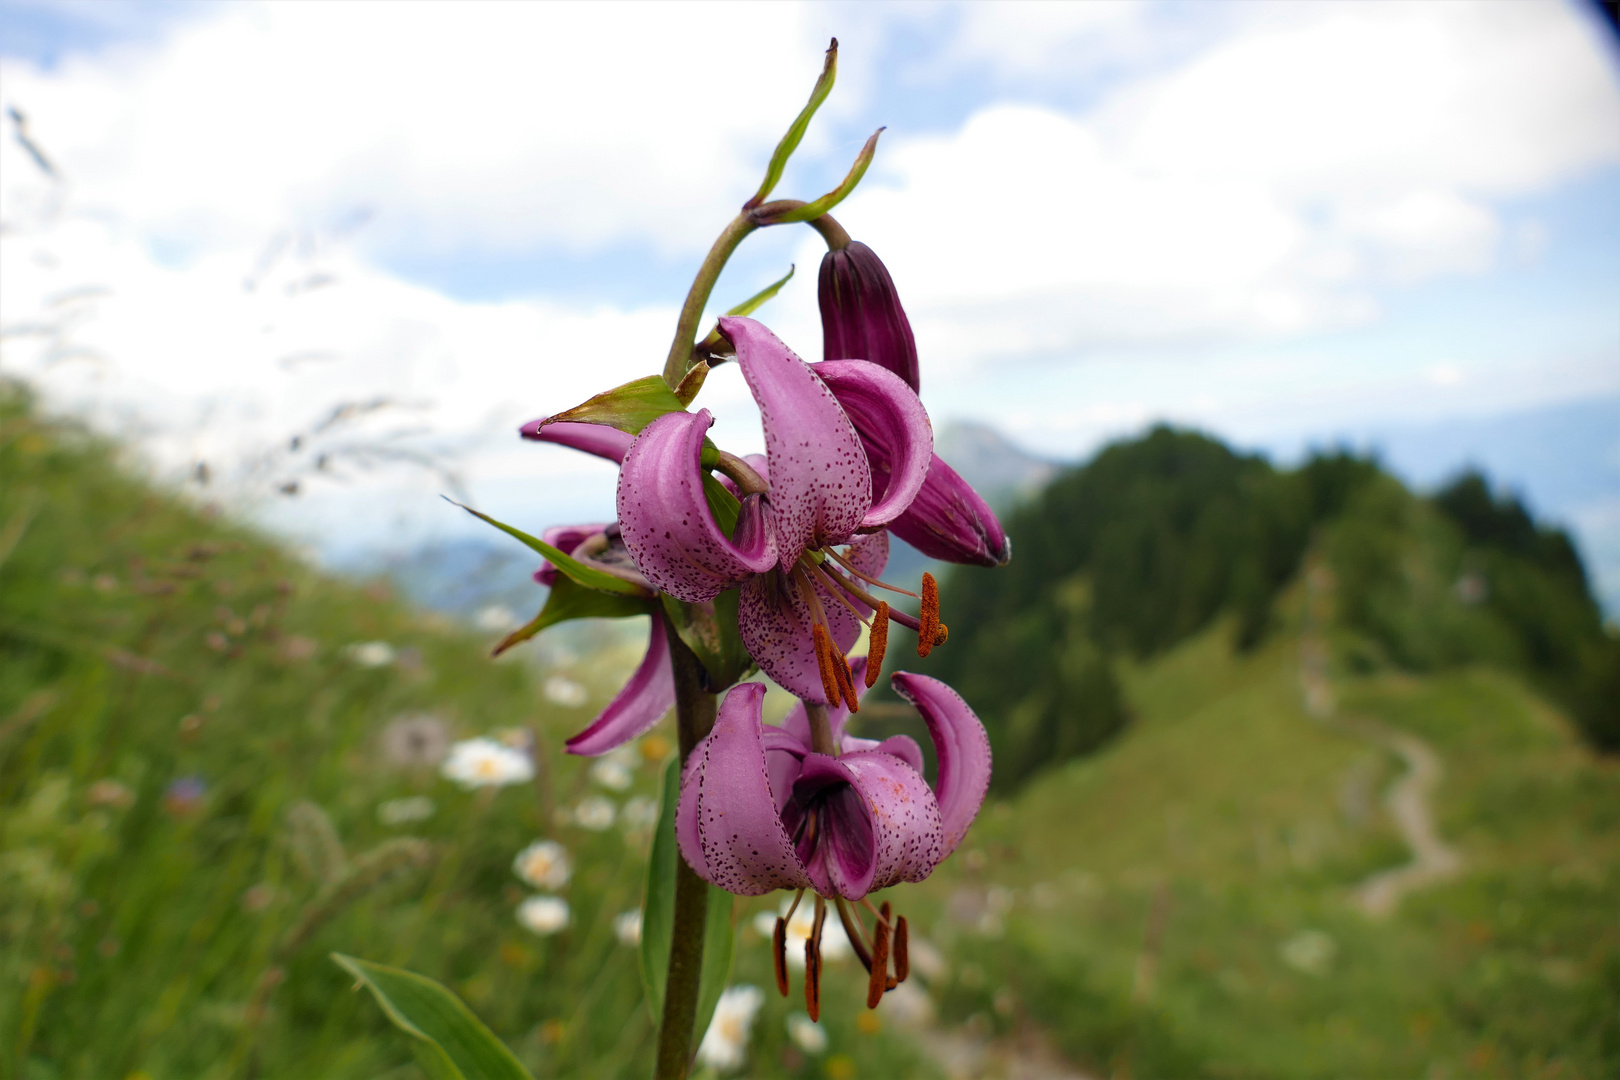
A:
[676,683,810,895]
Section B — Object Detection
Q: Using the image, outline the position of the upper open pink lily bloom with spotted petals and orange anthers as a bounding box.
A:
[615,317,933,704]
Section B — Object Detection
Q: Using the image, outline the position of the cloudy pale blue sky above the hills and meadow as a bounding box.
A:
[0,0,1620,596]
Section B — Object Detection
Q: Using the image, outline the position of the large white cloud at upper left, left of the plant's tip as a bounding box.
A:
[0,3,860,259]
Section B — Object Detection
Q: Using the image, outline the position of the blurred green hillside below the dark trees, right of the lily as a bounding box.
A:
[900,596,1620,1078]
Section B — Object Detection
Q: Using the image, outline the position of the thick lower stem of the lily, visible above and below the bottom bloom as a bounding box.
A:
[654,625,716,1080]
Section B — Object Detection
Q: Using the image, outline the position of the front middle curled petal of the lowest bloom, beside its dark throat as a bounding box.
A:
[782,751,943,900]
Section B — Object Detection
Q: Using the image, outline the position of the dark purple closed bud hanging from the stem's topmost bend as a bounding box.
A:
[818,241,917,390]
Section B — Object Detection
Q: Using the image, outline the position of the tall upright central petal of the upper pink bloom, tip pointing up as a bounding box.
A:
[719,316,872,568]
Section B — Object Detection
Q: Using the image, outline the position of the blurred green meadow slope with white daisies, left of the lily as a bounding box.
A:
[0,387,939,1080]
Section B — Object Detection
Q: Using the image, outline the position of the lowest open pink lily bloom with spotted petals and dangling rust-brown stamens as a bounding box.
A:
[676,657,990,1018]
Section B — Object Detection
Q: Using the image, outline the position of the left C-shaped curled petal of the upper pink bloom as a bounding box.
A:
[615,410,776,604]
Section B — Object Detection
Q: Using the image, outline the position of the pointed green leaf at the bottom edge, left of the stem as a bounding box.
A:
[332,952,533,1080]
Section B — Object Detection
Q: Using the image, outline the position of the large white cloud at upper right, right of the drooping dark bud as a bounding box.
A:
[822,3,1620,366]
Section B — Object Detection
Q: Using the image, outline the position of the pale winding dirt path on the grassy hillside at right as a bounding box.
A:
[1299,567,1463,918]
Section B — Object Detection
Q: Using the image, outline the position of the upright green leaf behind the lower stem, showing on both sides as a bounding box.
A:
[642,758,737,1043]
